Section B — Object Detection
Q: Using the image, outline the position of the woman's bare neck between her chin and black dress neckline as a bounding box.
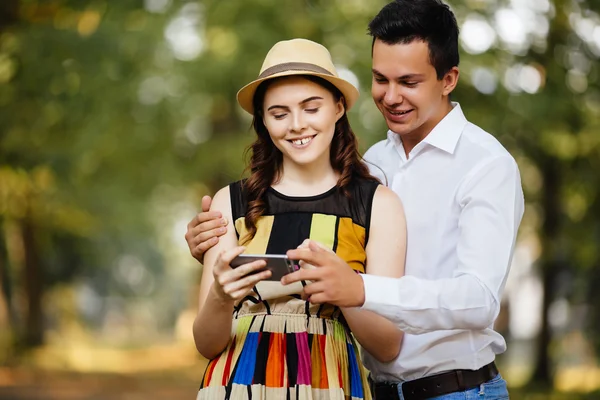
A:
[272,157,340,196]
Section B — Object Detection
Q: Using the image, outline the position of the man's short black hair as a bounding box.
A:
[369,0,459,79]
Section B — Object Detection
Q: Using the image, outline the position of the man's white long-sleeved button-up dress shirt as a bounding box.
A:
[362,103,524,382]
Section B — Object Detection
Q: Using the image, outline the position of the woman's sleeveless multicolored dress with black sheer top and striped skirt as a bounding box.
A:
[197,180,378,400]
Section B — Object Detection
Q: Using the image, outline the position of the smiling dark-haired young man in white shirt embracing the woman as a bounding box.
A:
[186,0,524,400]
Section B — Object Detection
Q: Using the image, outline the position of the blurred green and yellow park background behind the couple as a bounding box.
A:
[0,0,600,399]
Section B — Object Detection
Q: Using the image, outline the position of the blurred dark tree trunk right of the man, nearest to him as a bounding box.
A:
[532,159,561,387]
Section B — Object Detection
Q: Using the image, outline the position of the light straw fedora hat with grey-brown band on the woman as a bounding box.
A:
[237,39,358,114]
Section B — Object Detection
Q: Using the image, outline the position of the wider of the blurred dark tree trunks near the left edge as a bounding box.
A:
[21,219,44,347]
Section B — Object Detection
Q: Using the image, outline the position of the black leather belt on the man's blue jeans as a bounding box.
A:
[372,362,498,400]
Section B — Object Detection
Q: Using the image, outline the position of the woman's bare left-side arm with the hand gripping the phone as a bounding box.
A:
[193,187,271,359]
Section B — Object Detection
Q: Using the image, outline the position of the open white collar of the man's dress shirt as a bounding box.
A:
[386,102,468,154]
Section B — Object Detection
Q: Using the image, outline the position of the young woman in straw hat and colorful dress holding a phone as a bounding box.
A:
[194,39,406,399]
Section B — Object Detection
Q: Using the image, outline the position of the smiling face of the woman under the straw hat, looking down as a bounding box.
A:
[263,76,344,165]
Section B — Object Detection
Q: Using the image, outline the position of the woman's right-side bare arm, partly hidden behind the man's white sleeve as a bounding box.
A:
[342,186,406,362]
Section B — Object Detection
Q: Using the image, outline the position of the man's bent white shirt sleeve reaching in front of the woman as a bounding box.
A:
[362,156,524,335]
